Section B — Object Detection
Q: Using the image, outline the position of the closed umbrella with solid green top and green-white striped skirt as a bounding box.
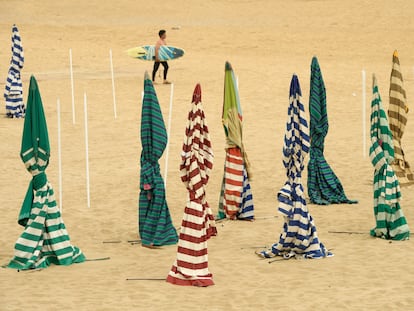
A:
[8,76,85,269]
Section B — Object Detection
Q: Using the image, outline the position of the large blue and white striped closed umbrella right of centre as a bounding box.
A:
[258,75,332,259]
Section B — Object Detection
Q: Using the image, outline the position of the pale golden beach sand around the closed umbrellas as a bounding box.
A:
[0,0,414,311]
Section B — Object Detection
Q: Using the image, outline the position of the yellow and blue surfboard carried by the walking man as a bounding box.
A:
[127,45,184,61]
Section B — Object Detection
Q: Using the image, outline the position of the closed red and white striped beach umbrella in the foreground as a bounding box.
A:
[167,84,217,286]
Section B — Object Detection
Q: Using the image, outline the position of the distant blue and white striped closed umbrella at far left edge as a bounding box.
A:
[4,25,25,118]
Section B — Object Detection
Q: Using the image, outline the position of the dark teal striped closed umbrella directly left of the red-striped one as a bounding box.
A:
[139,72,178,246]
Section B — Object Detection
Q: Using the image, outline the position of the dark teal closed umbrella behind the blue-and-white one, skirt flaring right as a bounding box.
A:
[308,57,357,205]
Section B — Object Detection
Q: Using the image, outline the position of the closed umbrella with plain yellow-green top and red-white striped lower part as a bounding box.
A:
[218,62,254,220]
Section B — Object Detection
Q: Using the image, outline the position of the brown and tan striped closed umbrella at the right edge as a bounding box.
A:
[388,51,414,185]
